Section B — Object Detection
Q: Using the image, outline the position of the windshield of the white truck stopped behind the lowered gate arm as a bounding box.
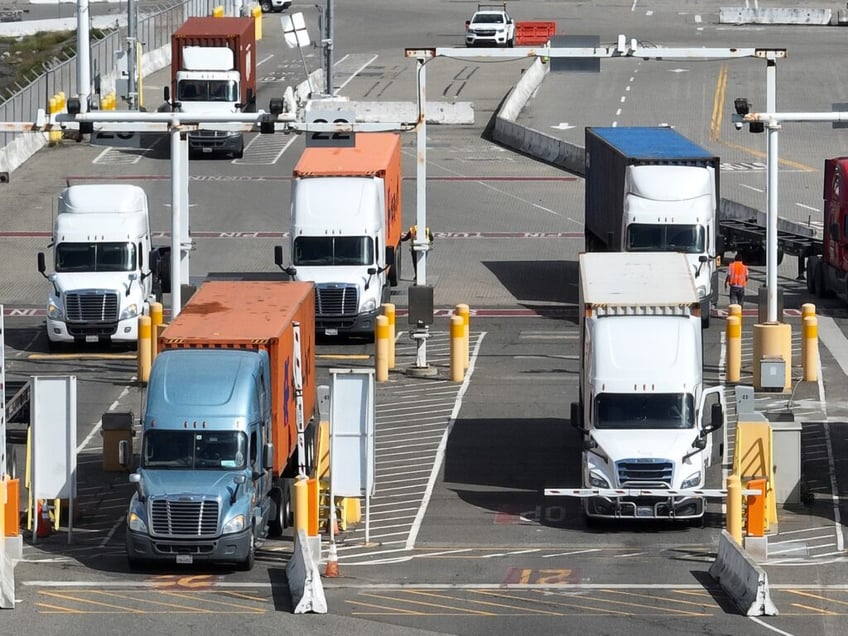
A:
[595,393,695,429]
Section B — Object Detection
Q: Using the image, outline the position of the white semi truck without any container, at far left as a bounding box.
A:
[38,184,158,349]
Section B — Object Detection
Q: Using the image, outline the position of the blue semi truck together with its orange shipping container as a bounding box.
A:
[124,281,317,570]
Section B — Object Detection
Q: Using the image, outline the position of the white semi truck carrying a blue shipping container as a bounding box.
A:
[584,126,720,327]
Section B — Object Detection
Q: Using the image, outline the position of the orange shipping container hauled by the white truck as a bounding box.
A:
[293,133,403,258]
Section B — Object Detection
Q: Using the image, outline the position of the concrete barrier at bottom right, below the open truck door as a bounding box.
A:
[710,530,778,616]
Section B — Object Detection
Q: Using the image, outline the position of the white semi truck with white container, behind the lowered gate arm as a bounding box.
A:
[571,252,724,520]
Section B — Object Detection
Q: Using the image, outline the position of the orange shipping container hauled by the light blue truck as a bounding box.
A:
[159,281,316,476]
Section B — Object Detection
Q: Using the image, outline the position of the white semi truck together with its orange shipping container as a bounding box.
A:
[274,133,402,337]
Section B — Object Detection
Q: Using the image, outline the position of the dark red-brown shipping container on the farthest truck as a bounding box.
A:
[171,16,256,103]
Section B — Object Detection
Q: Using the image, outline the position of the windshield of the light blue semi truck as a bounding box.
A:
[141,429,247,470]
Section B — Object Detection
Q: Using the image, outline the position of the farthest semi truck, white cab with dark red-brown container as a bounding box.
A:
[163,17,256,158]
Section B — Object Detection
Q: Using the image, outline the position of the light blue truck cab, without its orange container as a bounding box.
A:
[126,349,273,570]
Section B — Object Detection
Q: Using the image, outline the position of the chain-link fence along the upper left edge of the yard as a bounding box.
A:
[0,0,219,152]
